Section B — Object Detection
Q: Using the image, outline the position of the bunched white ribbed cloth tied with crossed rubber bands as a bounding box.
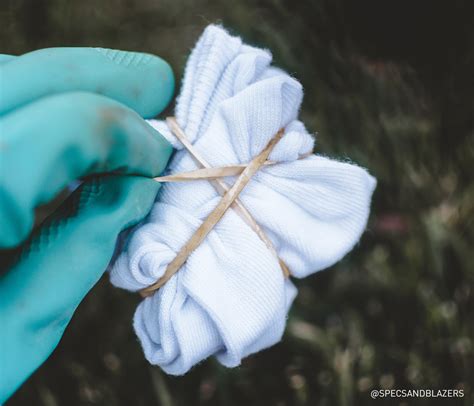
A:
[111,25,376,374]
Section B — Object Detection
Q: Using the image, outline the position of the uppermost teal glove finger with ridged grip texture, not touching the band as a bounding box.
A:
[0,48,174,117]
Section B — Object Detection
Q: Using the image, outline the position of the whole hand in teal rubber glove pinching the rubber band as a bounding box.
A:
[0,48,174,403]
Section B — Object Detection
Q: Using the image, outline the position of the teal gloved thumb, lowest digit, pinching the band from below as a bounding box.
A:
[0,176,160,403]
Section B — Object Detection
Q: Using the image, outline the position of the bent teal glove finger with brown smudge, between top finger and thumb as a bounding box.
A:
[0,93,172,247]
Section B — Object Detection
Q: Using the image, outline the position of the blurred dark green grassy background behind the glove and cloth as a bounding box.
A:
[0,0,474,406]
